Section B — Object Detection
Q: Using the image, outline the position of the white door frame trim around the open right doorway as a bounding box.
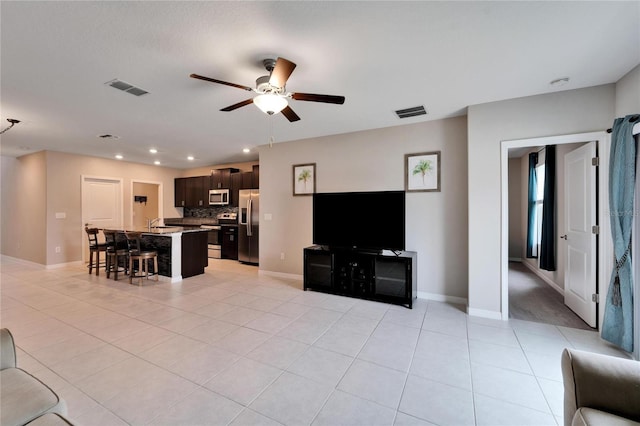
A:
[500,131,613,330]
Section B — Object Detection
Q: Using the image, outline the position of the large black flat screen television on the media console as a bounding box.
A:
[313,191,405,251]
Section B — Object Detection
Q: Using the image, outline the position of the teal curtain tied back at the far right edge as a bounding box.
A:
[602,115,636,352]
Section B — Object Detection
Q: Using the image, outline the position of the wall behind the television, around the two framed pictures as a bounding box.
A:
[260,117,467,301]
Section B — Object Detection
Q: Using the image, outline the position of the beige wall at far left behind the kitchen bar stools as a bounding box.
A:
[2,151,181,265]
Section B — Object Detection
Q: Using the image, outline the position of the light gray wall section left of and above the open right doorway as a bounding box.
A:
[468,84,615,317]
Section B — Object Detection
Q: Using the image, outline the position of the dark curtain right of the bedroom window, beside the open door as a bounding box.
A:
[539,145,556,271]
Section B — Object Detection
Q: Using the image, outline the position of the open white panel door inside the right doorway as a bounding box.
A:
[561,142,597,328]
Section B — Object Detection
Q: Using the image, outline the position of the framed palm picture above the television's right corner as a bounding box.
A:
[404,151,440,192]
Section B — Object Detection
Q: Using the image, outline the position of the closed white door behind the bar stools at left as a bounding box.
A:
[82,176,123,262]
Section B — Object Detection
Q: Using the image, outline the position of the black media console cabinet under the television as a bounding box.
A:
[304,246,418,309]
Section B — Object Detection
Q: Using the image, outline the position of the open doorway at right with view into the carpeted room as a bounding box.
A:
[508,142,598,330]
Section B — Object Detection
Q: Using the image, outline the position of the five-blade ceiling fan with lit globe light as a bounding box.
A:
[190,58,344,122]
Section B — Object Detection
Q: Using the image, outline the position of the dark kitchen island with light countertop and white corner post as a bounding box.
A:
[105,226,208,282]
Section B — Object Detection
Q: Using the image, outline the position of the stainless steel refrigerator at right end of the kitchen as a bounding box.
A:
[238,189,260,265]
